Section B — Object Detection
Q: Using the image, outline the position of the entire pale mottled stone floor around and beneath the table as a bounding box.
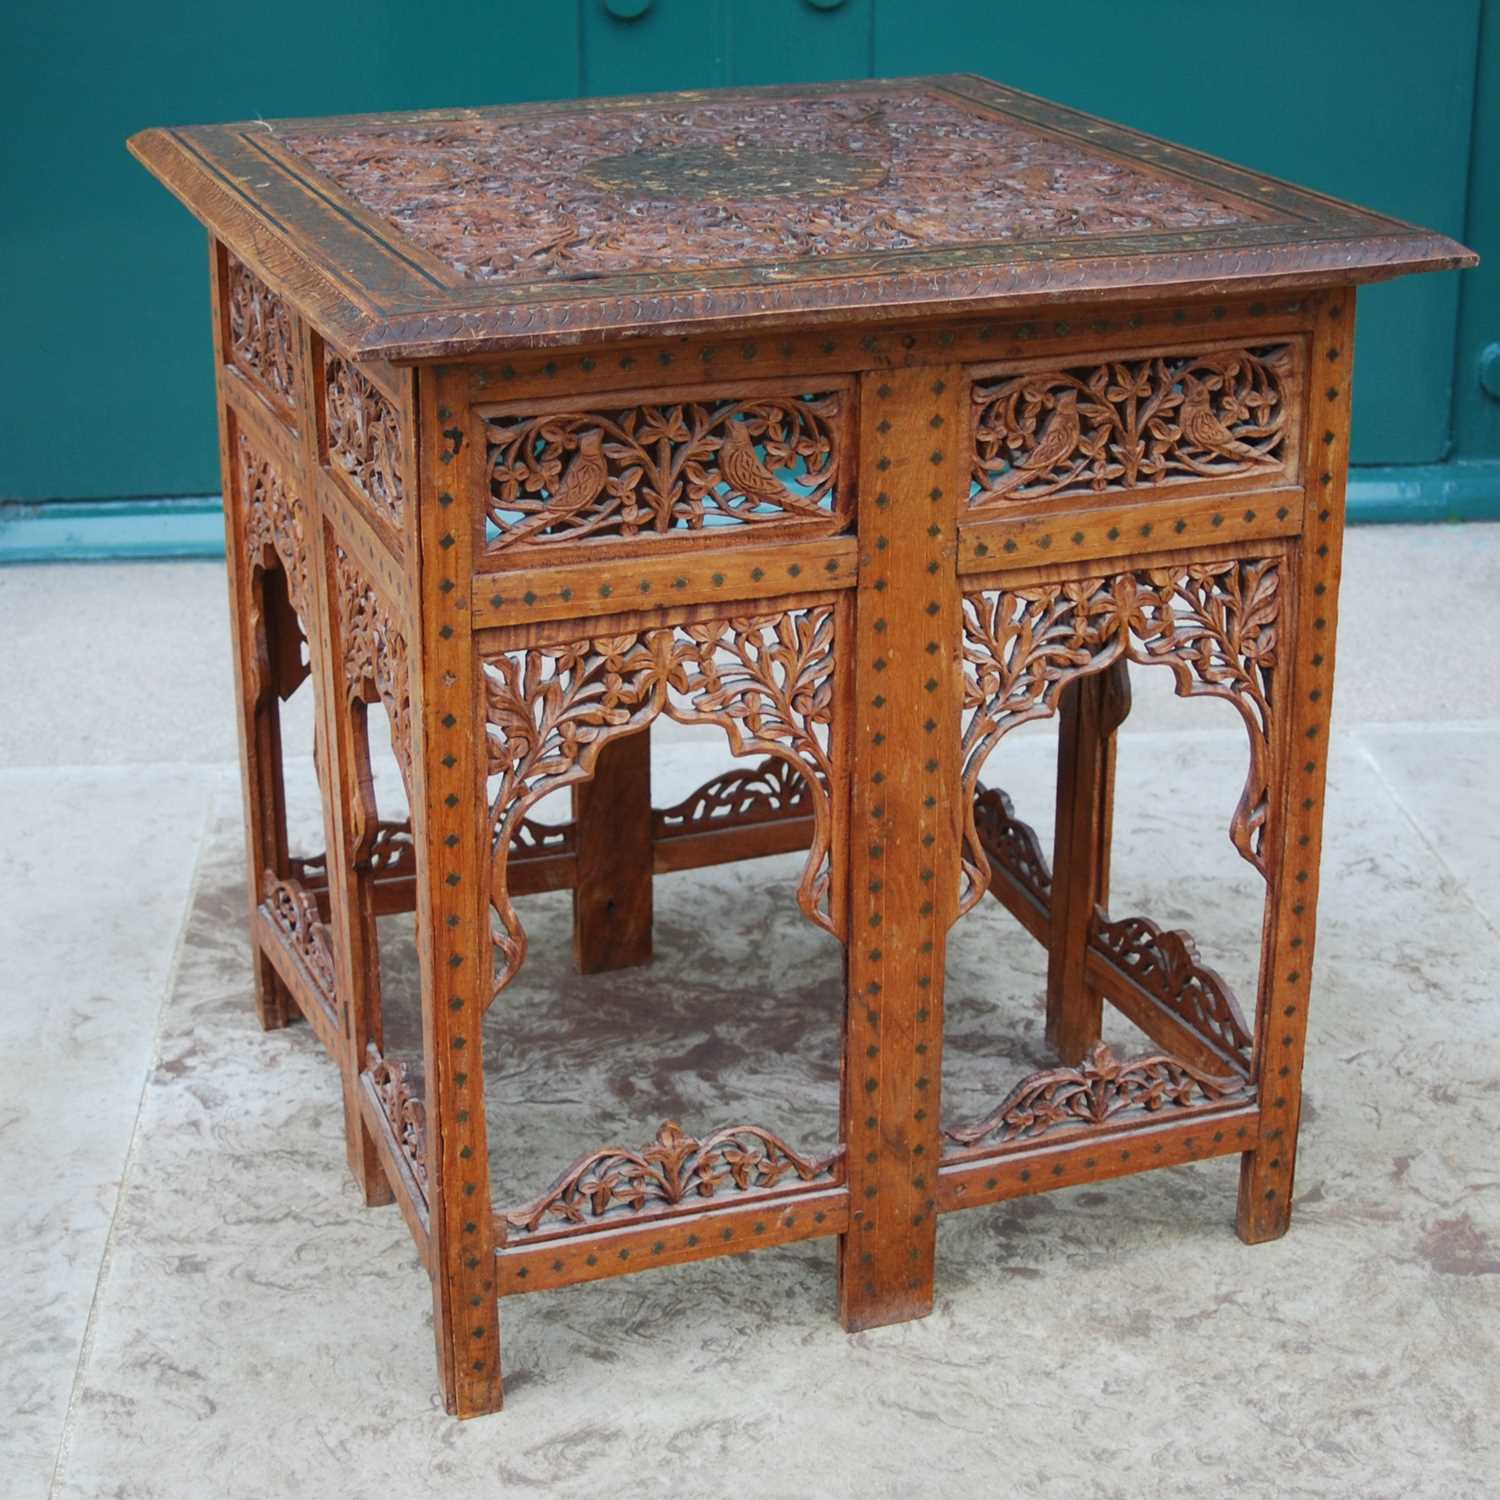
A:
[0,527,1500,1500]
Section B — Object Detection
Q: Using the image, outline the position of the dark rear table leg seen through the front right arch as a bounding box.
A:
[1047,659,1130,1067]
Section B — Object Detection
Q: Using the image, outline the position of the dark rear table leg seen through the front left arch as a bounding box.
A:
[573,729,653,974]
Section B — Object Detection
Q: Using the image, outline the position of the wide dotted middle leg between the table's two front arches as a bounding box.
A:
[839,366,968,1331]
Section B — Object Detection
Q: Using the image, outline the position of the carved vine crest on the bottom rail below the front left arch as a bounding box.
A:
[504,1121,843,1235]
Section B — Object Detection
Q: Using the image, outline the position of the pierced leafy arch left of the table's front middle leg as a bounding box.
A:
[483,605,837,993]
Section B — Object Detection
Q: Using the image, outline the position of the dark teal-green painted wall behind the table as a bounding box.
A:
[0,0,1500,500]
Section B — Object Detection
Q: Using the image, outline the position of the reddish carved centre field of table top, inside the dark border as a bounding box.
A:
[282,86,1260,291]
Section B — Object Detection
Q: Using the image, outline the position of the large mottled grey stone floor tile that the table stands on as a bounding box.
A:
[46,732,1500,1500]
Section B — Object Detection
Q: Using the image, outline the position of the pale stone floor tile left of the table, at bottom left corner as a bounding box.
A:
[0,767,224,1500]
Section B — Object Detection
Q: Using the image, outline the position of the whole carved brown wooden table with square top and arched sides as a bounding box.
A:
[131,78,1473,1416]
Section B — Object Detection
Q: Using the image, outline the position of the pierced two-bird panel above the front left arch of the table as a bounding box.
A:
[485,390,851,554]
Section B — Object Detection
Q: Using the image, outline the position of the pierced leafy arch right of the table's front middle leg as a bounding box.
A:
[960,558,1281,912]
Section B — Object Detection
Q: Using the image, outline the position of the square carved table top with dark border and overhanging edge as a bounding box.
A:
[129,75,1475,360]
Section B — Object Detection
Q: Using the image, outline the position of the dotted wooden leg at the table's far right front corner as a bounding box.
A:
[1238,291,1355,1244]
